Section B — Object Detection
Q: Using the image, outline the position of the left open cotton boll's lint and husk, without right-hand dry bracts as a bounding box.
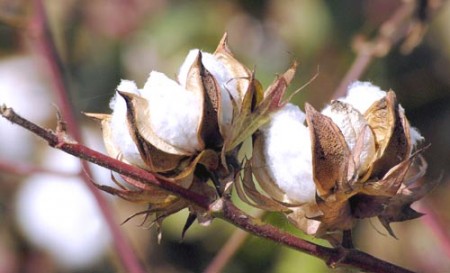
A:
[87,35,255,211]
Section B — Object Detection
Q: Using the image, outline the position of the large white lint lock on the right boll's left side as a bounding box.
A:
[261,104,316,203]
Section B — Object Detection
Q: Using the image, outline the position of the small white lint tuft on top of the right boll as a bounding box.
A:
[339,81,386,114]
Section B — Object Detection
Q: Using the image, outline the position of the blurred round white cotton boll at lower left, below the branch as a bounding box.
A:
[16,151,111,269]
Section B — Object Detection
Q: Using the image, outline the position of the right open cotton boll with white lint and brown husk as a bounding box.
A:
[244,82,433,244]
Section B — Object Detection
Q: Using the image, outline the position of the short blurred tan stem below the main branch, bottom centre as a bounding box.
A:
[203,210,265,273]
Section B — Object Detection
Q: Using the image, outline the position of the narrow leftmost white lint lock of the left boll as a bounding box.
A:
[109,80,145,167]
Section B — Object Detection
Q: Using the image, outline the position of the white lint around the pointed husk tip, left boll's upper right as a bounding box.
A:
[178,49,236,125]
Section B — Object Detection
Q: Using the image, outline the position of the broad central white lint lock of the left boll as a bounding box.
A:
[141,71,202,153]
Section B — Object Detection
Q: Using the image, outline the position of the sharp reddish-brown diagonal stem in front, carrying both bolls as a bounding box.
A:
[0,105,412,273]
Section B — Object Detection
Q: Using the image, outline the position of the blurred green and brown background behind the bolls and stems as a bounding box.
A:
[0,0,450,273]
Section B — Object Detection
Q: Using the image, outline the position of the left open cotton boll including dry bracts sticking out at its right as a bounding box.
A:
[87,34,296,225]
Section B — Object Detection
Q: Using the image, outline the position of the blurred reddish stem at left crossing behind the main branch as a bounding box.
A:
[29,0,144,273]
